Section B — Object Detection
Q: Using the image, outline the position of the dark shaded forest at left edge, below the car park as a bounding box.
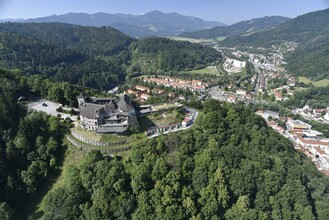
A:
[0,70,67,219]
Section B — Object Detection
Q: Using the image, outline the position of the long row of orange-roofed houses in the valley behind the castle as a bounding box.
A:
[143,77,208,92]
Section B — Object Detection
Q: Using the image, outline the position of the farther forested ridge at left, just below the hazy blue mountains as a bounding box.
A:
[0,23,135,56]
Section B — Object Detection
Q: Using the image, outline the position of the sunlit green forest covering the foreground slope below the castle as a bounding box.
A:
[39,100,329,220]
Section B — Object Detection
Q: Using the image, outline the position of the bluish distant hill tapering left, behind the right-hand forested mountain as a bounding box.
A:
[179,16,290,39]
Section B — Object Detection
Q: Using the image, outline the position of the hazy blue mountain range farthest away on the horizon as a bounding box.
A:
[0,11,224,37]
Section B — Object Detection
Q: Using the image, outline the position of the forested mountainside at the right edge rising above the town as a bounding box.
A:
[221,9,329,80]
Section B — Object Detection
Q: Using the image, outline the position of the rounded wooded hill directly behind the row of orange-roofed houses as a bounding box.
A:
[131,38,221,73]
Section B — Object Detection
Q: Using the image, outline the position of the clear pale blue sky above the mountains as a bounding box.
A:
[0,0,329,24]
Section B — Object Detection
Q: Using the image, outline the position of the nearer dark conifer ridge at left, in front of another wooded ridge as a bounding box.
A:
[0,32,125,89]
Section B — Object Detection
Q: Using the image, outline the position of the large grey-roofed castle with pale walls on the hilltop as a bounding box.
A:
[77,93,139,134]
